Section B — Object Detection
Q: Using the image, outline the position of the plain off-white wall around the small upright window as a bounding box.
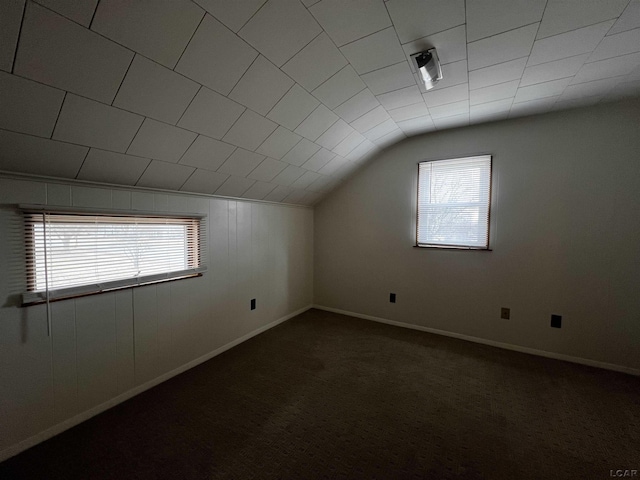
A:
[314,101,640,369]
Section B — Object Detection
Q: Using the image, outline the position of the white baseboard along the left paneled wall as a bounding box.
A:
[0,305,312,462]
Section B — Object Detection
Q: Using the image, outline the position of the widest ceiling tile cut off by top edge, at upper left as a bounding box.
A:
[91,0,204,68]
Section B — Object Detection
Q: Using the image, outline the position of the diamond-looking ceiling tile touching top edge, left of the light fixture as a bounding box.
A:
[238,0,322,67]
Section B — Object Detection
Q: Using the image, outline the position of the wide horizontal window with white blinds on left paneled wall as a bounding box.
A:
[23,206,205,304]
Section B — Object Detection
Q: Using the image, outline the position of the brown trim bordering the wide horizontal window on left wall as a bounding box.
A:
[18,204,207,306]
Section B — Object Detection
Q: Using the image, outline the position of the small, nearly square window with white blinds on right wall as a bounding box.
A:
[417,155,491,250]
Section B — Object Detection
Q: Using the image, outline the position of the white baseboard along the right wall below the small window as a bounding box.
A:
[313,305,640,376]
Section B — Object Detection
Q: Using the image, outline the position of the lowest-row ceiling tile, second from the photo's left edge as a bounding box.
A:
[78,148,151,185]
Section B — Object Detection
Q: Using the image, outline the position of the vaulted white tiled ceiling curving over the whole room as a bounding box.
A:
[0,0,640,205]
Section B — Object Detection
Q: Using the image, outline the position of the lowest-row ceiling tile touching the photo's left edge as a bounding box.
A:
[0,130,89,178]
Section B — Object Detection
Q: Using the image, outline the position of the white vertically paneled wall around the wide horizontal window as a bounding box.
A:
[0,178,313,460]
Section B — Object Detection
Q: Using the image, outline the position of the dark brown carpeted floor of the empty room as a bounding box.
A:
[0,310,640,480]
